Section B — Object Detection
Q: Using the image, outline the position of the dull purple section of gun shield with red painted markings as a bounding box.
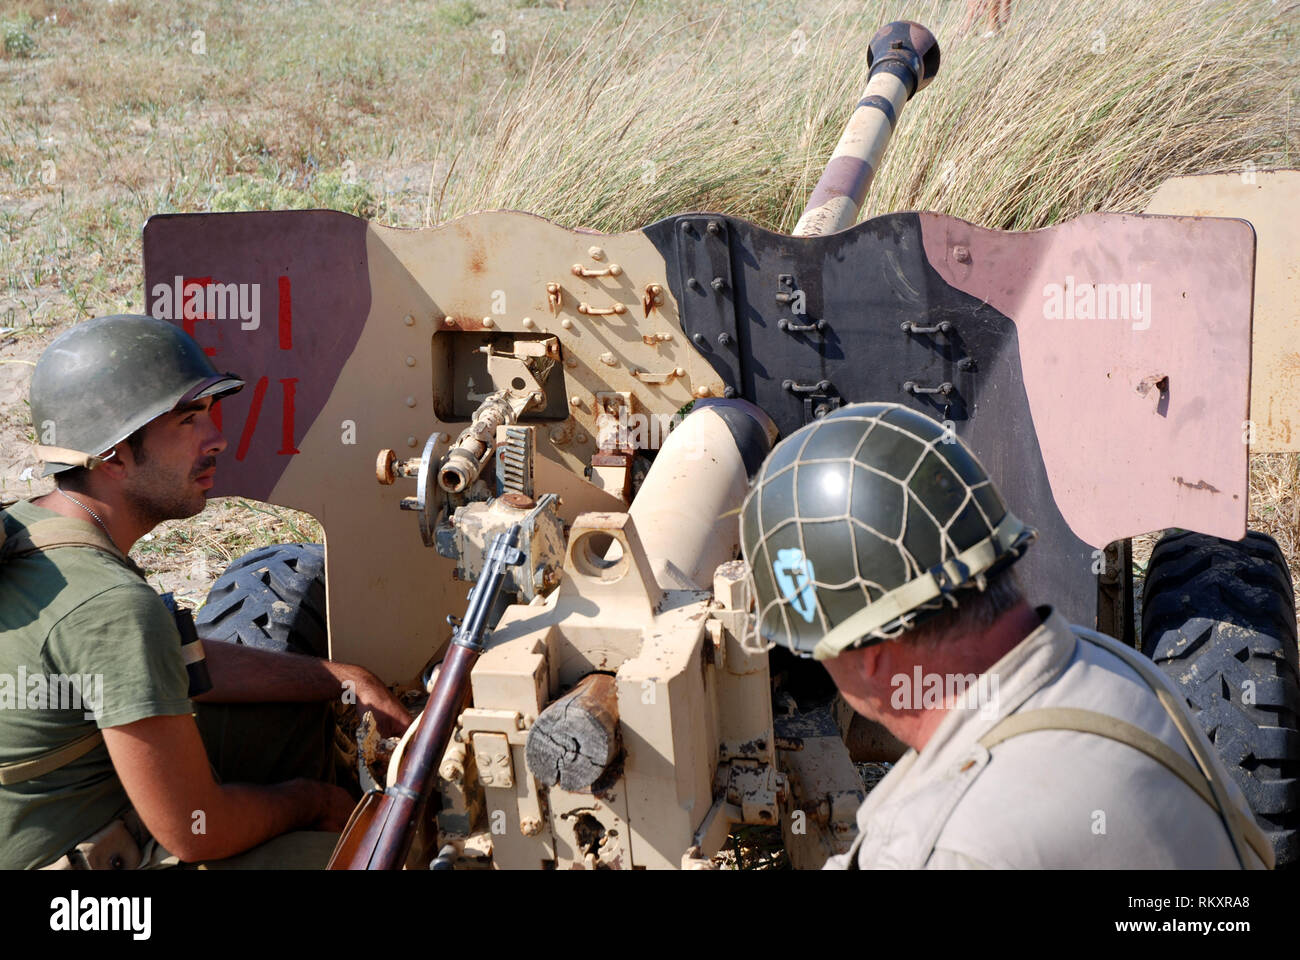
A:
[143,211,371,500]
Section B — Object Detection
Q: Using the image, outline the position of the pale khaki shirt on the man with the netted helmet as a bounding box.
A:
[826,607,1261,869]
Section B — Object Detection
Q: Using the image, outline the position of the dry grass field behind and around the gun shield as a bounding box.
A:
[0,0,1300,621]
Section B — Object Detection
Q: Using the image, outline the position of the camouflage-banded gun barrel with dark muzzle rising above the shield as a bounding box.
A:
[794,21,939,237]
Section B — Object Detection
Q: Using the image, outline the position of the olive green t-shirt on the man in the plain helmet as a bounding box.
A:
[0,501,194,869]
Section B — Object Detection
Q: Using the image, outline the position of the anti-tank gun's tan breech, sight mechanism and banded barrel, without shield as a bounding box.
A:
[332,25,939,868]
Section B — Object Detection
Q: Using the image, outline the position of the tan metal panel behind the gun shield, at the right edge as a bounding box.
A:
[1147,169,1300,453]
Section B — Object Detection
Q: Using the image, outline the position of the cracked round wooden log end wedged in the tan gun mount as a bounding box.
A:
[524,674,619,791]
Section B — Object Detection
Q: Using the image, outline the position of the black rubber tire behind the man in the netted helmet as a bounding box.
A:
[1141,532,1300,868]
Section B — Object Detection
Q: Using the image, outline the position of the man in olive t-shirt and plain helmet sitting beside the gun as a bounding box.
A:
[0,315,410,869]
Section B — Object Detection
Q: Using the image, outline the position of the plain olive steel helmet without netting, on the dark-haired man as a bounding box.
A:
[31,313,243,476]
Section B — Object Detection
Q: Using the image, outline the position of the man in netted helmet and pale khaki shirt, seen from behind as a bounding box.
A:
[740,403,1273,869]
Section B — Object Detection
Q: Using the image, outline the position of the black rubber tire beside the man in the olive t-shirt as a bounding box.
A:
[195,544,329,657]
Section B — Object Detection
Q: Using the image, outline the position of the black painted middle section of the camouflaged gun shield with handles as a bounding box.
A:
[645,213,1097,626]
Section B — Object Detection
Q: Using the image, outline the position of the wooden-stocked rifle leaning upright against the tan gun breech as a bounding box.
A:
[328,523,524,870]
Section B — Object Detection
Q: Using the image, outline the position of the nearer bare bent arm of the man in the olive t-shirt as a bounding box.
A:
[103,712,354,862]
